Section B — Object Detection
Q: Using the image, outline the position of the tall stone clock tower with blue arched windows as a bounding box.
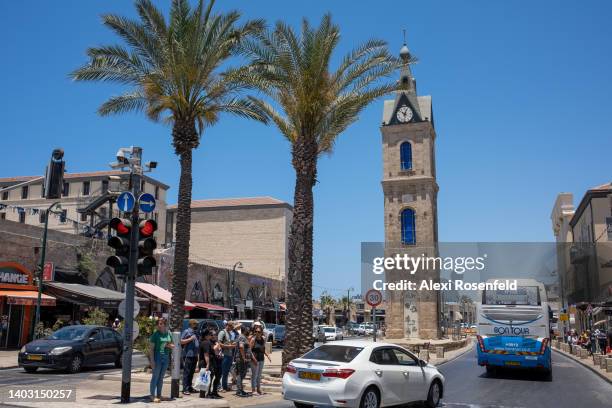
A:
[381,44,439,339]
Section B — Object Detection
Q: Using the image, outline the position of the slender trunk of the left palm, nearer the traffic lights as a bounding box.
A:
[170,121,198,331]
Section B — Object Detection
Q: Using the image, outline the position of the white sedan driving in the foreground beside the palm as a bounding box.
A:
[282,340,444,408]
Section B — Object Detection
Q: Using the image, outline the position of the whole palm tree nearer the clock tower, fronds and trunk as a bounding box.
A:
[241,15,399,367]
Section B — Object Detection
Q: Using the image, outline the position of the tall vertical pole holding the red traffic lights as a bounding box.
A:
[121,162,142,403]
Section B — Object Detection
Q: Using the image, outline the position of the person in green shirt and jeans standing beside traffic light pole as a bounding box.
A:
[149,318,174,402]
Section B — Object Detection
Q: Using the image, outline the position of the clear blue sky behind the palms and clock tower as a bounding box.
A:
[0,0,612,295]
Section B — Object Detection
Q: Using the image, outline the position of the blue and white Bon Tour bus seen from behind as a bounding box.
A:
[476,279,552,375]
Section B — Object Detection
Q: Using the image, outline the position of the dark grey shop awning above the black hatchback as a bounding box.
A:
[44,282,147,309]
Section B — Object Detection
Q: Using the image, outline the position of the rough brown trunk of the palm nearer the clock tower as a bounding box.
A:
[283,138,317,371]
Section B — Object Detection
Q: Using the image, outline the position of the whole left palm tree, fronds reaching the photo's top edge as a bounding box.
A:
[71,0,267,330]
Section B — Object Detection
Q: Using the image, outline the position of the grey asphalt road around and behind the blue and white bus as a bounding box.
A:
[255,350,612,408]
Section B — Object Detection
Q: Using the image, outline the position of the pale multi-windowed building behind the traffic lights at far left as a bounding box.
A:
[0,171,169,241]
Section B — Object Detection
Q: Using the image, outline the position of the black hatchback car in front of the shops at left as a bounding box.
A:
[17,325,123,373]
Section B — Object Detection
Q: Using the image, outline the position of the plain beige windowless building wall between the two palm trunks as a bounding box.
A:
[166,197,293,281]
